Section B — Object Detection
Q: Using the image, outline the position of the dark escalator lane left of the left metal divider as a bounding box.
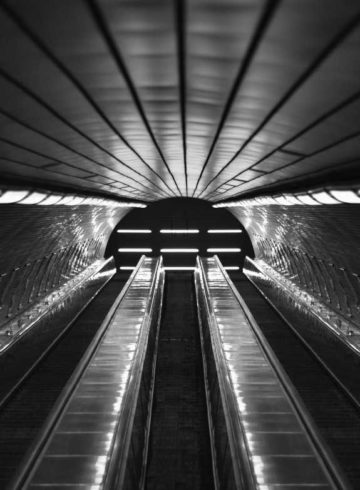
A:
[0,276,125,489]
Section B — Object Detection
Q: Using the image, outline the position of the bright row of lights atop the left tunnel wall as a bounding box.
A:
[0,187,146,208]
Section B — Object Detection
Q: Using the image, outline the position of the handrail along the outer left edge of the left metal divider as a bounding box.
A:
[9,255,150,490]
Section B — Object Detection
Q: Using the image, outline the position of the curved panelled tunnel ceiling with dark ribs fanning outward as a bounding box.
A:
[0,0,360,201]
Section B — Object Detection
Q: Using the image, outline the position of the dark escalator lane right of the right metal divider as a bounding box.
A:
[234,274,360,488]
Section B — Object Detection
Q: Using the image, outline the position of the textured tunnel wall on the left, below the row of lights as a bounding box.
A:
[0,204,128,325]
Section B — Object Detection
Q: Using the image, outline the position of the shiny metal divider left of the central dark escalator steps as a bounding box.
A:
[18,258,161,490]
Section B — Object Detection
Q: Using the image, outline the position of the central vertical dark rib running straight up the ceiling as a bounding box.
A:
[175,0,188,196]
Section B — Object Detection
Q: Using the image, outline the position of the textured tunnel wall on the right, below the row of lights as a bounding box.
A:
[232,204,360,323]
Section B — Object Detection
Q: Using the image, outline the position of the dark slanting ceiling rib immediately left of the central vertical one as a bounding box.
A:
[85,0,182,196]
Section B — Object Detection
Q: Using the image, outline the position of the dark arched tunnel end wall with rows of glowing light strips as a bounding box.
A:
[106,198,254,269]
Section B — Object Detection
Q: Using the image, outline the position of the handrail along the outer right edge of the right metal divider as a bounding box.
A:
[215,255,349,490]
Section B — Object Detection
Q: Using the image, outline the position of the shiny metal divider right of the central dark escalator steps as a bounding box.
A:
[197,257,345,490]
